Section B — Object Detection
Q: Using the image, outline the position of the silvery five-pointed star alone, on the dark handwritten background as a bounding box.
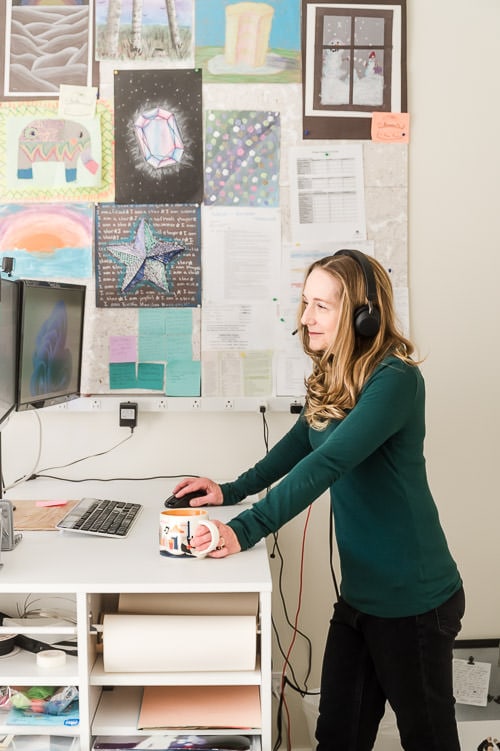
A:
[108,219,185,292]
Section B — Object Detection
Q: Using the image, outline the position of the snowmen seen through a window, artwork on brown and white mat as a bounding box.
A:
[302,0,406,138]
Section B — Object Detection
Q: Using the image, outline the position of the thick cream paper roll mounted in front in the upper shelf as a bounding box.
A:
[103,614,257,673]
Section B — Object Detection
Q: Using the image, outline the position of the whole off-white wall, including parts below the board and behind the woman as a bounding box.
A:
[3,0,500,749]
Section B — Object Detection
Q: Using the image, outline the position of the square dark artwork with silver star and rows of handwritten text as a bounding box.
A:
[96,204,201,308]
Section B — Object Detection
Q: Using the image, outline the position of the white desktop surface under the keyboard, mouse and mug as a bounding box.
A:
[0,478,271,593]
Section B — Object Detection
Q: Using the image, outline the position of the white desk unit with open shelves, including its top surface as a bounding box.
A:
[0,479,272,751]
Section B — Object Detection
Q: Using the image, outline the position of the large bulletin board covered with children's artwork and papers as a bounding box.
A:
[0,0,409,400]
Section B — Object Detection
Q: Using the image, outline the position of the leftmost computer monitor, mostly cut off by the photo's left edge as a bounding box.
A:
[0,277,19,429]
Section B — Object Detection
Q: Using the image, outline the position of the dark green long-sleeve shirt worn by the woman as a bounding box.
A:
[222,357,461,617]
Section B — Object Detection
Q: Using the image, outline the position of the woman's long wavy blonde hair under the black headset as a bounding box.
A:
[298,255,416,430]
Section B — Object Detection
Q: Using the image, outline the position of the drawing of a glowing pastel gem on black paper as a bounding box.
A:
[114,70,203,204]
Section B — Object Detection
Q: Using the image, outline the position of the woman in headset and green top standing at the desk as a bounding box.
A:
[174,251,464,751]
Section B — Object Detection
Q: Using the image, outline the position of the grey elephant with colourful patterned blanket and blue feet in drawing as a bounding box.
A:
[17,118,99,183]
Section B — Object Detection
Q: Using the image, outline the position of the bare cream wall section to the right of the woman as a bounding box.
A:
[408,0,500,637]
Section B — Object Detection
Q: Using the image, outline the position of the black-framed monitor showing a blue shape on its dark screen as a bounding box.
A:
[16,279,86,410]
